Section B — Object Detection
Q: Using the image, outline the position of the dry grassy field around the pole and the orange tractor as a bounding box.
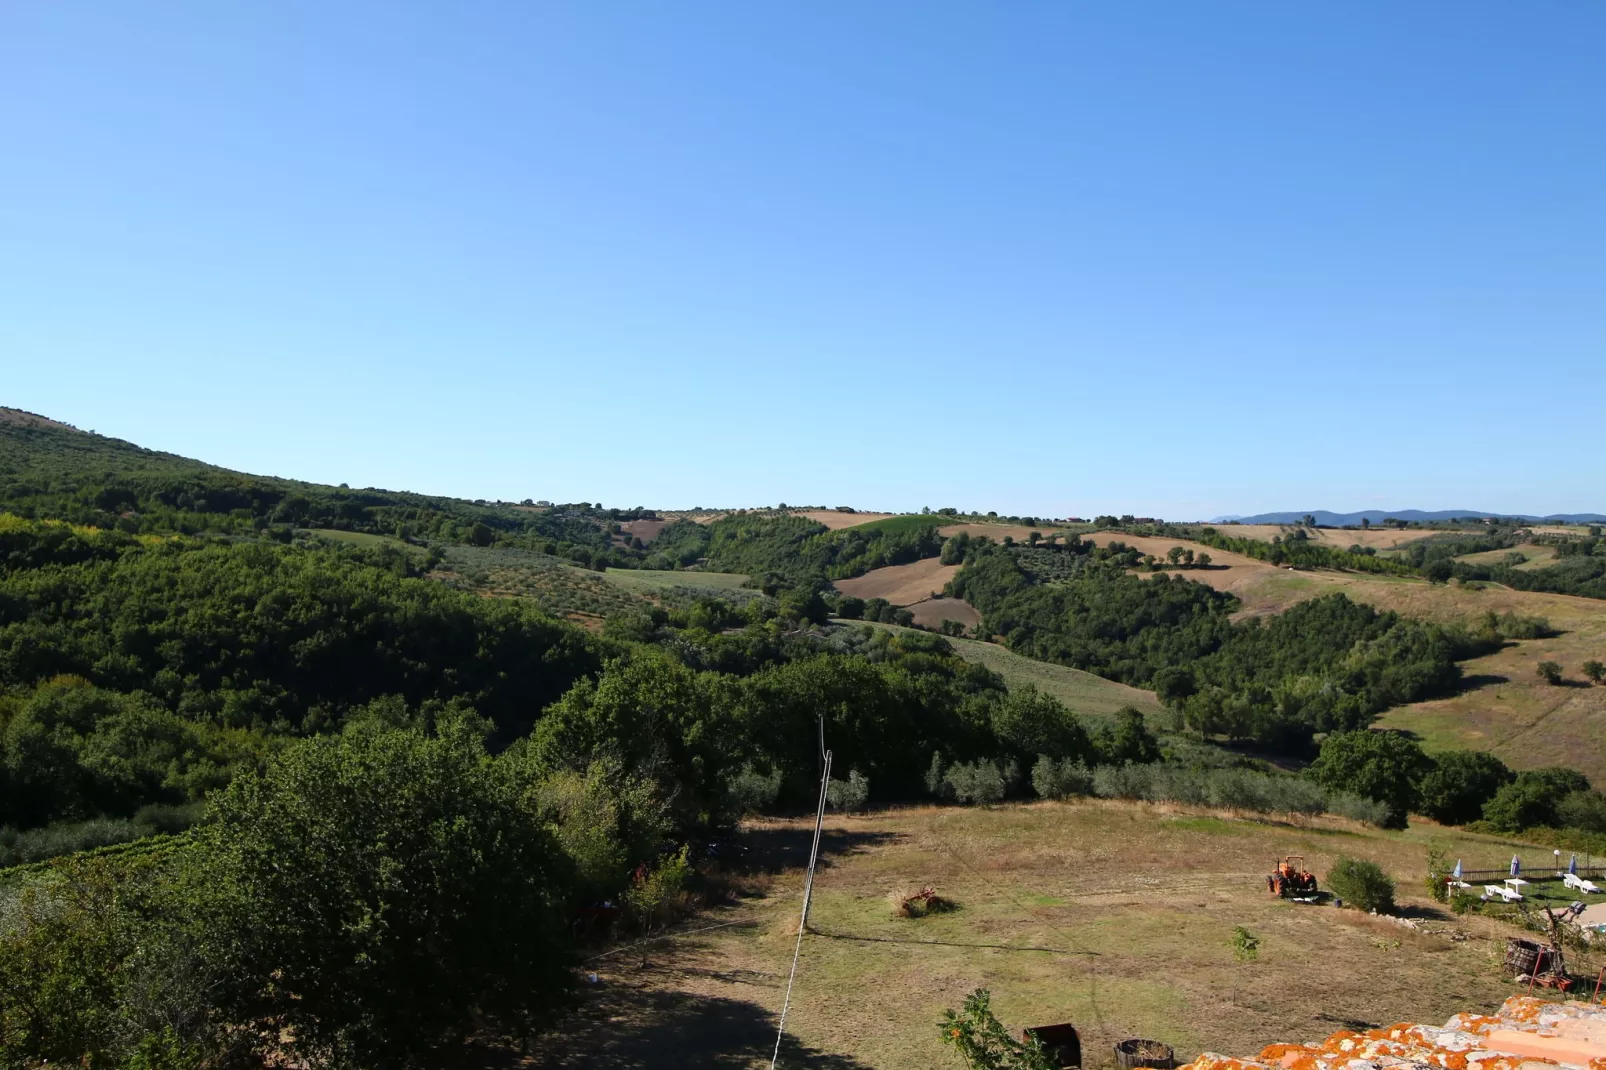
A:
[533,802,1561,1070]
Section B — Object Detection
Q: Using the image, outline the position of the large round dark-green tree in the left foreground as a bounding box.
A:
[191,726,570,1067]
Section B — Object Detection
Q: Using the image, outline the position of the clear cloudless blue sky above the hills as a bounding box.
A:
[0,0,1606,519]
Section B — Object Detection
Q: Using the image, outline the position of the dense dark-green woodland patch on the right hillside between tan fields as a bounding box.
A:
[944,537,1532,753]
